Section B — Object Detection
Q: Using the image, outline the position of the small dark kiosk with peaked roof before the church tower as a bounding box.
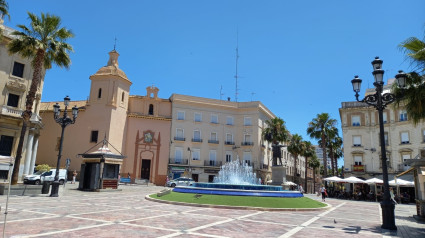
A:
[78,139,125,191]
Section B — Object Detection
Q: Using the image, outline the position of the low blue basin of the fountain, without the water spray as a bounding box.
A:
[173,183,303,198]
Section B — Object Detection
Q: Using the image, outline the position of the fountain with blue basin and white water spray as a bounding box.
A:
[173,160,303,197]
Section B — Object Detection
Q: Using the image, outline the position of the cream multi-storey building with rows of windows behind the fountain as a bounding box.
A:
[169,94,275,182]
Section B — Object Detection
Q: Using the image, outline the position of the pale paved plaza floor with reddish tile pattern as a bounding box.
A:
[0,184,425,238]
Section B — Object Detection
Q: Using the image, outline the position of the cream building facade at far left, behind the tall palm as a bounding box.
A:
[0,23,45,181]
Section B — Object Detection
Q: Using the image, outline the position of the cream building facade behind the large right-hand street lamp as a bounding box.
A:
[339,80,425,178]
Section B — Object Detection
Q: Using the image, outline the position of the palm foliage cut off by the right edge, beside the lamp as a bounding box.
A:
[393,33,425,125]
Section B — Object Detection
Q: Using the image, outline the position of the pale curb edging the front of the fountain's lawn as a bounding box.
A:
[145,193,332,212]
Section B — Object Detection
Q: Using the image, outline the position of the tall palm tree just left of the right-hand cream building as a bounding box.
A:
[307,113,336,177]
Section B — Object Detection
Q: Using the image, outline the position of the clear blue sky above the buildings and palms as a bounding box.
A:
[5,0,425,165]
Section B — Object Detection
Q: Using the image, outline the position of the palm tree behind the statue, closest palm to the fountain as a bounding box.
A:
[262,117,290,166]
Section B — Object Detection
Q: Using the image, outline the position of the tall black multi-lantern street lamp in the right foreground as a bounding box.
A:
[351,57,406,230]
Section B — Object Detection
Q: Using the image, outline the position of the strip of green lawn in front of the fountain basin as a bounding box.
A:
[150,192,326,208]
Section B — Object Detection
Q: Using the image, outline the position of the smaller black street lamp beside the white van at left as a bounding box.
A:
[50,96,78,197]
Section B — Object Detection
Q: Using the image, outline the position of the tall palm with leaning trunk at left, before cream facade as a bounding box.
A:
[8,12,74,184]
